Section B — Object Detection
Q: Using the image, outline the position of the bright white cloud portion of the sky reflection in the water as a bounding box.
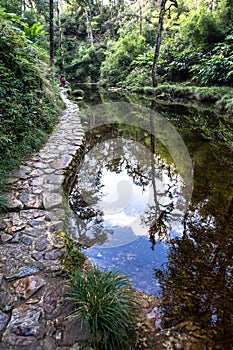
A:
[79,160,185,236]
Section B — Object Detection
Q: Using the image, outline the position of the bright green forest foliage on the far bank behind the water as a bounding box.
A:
[51,0,233,90]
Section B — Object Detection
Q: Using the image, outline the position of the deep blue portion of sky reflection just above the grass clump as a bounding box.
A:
[84,237,166,295]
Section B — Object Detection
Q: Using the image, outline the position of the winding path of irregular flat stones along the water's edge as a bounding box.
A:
[0,90,90,350]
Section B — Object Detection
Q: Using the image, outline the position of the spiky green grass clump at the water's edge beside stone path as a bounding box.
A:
[66,267,135,350]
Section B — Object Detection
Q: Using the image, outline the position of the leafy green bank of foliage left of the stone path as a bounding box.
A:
[0,9,59,211]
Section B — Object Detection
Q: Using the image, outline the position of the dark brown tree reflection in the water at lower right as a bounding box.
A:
[155,148,233,349]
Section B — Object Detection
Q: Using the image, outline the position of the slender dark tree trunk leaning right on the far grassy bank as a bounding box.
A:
[152,0,167,87]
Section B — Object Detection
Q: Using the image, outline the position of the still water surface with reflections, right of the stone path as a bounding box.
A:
[70,87,233,349]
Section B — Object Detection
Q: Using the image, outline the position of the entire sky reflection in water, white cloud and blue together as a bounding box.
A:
[71,145,187,295]
